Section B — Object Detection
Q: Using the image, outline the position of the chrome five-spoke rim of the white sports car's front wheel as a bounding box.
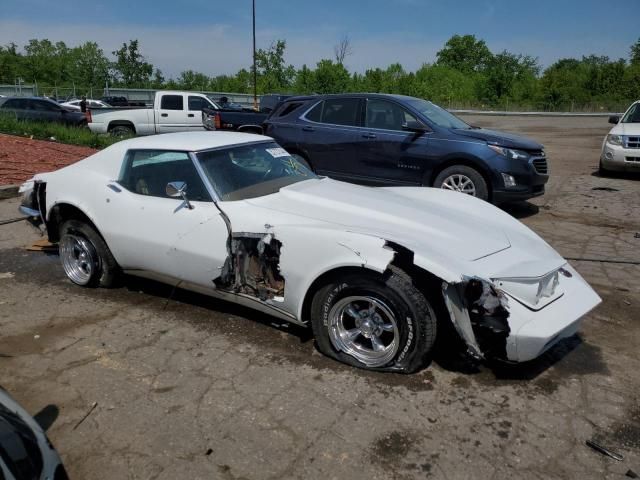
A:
[329,296,400,367]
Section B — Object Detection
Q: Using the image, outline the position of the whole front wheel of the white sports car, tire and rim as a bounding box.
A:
[311,268,436,373]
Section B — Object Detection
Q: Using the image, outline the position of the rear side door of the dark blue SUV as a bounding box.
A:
[296,97,361,178]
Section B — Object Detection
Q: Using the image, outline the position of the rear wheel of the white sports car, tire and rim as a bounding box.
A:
[59,220,120,287]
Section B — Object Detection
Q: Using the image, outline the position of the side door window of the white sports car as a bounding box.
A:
[118,150,211,202]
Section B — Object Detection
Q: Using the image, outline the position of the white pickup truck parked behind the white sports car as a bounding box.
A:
[87,90,220,136]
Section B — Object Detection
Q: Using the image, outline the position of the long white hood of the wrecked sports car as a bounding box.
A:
[248,179,564,276]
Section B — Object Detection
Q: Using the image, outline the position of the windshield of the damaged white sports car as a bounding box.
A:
[197,142,318,201]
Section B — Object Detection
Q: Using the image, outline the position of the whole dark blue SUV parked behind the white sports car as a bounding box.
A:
[263,93,549,203]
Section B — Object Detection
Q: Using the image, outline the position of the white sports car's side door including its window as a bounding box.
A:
[97,150,228,287]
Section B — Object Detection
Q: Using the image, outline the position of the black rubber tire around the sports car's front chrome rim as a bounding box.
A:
[311,276,432,373]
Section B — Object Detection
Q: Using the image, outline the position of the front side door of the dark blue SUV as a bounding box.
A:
[358,97,429,185]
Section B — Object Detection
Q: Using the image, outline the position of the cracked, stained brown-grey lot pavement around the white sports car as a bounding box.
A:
[0,116,640,480]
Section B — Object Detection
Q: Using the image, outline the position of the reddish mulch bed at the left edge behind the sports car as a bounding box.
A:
[0,134,97,185]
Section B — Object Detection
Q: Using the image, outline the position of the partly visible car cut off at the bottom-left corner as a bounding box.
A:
[0,387,68,480]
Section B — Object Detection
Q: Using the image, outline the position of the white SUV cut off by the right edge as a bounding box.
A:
[600,100,640,173]
